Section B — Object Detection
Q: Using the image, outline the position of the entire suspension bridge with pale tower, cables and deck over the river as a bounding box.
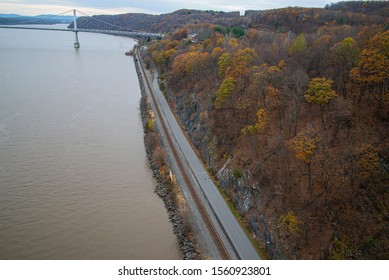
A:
[0,9,162,49]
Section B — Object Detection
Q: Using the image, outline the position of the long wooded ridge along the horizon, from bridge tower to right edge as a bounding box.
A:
[69,1,389,33]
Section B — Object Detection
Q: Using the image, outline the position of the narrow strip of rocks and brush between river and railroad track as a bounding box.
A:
[134,50,201,260]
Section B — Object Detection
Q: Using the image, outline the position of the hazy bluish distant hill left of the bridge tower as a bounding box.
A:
[0,14,73,24]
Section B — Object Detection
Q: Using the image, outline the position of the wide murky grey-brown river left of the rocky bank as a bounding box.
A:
[0,26,180,259]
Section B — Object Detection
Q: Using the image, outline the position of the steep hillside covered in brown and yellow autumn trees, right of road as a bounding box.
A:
[138,2,389,259]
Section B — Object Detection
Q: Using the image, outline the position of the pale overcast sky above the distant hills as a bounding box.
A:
[0,0,335,15]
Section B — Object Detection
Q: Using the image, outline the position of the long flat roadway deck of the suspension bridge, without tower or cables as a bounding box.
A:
[0,25,162,37]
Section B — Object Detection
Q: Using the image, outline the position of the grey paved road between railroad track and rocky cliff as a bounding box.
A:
[136,47,260,260]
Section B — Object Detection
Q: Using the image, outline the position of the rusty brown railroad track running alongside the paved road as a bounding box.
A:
[135,48,230,260]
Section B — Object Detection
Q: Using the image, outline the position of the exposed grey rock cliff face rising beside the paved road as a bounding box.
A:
[166,85,285,259]
